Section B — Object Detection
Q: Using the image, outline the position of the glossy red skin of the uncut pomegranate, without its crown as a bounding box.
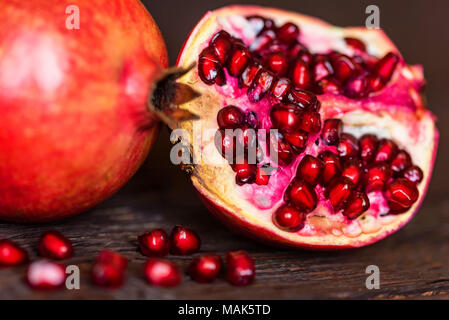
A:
[0,0,168,222]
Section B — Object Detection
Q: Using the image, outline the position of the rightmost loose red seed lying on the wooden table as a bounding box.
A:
[226,251,256,286]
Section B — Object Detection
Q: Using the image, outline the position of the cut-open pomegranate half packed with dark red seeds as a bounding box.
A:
[178,6,438,249]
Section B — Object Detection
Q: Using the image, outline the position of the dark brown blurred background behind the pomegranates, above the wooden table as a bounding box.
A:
[135,0,449,201]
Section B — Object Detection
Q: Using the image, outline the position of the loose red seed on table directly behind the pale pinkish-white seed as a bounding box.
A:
[38,230,73,260]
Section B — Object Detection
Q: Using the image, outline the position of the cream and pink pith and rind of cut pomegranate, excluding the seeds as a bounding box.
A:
[178,6,438,249]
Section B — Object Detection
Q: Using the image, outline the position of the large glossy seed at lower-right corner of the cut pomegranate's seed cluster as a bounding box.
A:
[384,178,419,213]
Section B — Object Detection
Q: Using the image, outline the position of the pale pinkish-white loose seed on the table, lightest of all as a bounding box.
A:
[26,260,67,290]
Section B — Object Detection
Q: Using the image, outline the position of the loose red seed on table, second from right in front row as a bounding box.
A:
[189,254,222,283]
